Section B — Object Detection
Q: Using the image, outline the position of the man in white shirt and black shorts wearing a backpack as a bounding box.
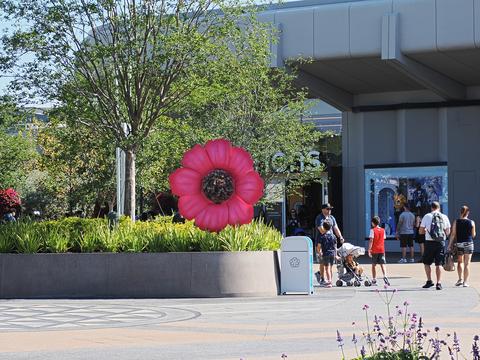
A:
[419,201,450,290]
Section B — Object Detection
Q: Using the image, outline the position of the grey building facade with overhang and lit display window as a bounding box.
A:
[261,0,480,250]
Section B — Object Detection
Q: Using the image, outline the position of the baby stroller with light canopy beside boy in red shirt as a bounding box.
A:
[335,243,372,286]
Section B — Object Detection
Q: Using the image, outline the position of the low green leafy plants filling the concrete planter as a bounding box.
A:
[0,217,282,254]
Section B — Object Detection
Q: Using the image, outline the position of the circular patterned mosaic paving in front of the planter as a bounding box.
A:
[0,302,200,331]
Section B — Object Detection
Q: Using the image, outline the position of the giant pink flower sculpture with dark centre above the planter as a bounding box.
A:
[170,139,264,231]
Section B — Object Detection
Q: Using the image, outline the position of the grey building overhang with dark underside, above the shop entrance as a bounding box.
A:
[260,0,480,111]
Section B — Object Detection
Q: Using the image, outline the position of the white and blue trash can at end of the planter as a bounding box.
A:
[280,236,313,295]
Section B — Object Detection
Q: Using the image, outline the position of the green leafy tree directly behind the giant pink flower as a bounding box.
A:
[182,25,325,193]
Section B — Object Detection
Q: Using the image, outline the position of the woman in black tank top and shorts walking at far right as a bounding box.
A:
[448,205,476,287]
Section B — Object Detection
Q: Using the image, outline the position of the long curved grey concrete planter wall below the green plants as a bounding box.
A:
[0,251,280,299]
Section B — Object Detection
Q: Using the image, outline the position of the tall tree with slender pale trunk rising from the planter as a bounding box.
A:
[1,0,266,217]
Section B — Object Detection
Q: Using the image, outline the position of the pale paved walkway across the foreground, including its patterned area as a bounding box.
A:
[0,262,480,360]
